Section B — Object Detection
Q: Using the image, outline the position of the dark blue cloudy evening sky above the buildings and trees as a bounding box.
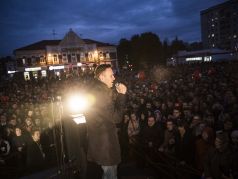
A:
[0,0,225,56]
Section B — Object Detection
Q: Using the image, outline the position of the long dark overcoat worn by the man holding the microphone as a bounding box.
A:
[86,80,125,166]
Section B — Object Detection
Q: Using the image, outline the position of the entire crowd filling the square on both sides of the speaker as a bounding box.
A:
[0,62,238,178]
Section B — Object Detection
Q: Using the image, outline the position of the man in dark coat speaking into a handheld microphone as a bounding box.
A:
[86,64,127,179]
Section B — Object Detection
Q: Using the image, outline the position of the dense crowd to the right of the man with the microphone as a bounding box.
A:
[117,62,238,178]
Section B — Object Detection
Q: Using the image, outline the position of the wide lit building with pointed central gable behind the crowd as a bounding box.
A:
[14,29,118,78]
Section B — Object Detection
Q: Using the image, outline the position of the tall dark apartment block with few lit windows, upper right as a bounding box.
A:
[200,0,238,51]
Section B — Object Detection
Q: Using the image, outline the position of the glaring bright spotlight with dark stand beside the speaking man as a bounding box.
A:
[65,93,91,179]
